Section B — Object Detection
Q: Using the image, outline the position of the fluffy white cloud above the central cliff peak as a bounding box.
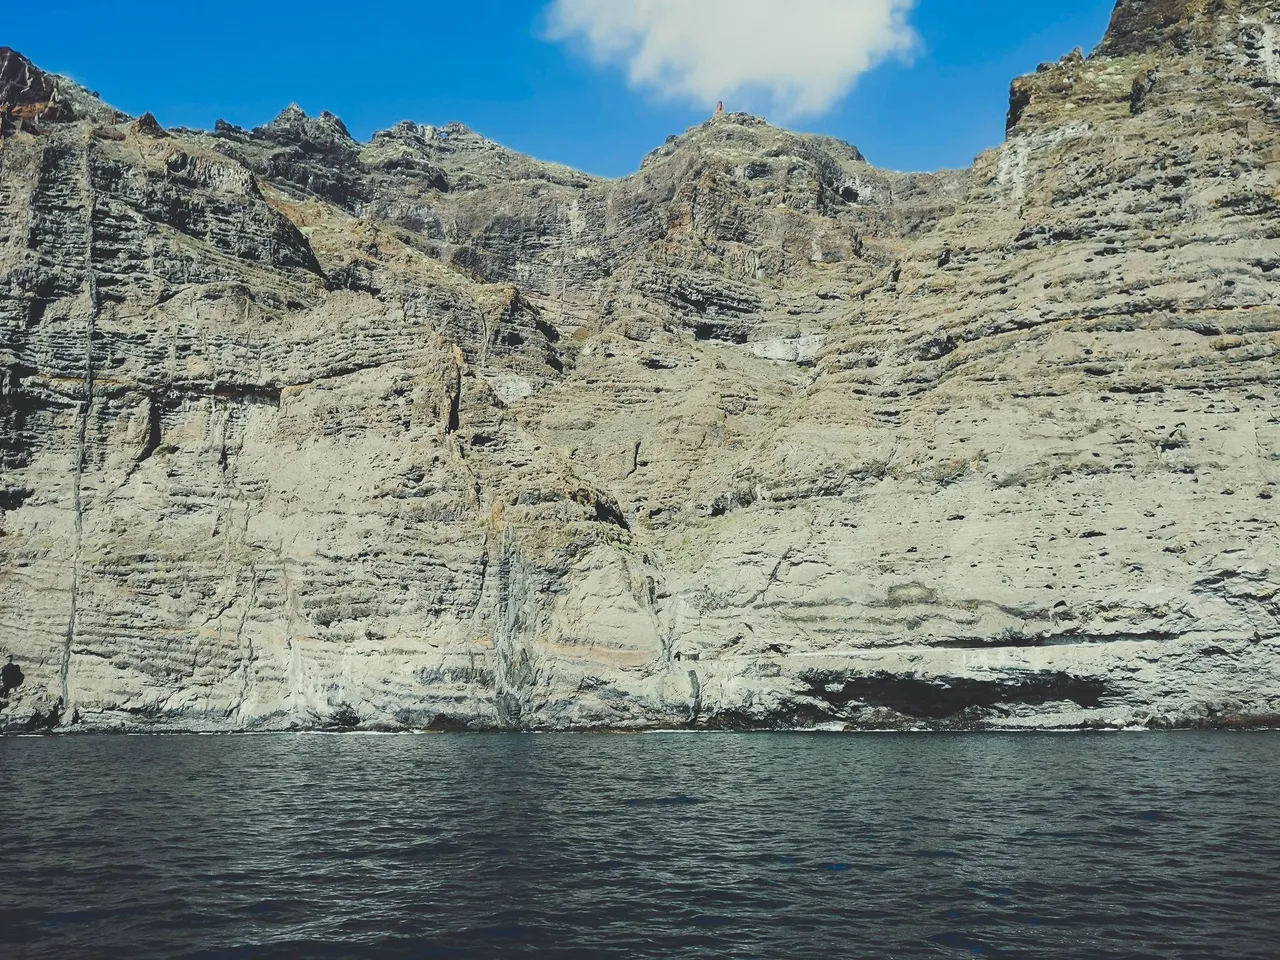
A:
[548,0,915,116]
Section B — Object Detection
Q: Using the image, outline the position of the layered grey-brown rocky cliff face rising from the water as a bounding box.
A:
[0,0,1280,730]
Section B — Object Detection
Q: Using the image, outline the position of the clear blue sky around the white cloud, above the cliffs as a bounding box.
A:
[0,0,1114,175]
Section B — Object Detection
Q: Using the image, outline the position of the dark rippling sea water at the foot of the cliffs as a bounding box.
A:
[0,733,1280,960]
